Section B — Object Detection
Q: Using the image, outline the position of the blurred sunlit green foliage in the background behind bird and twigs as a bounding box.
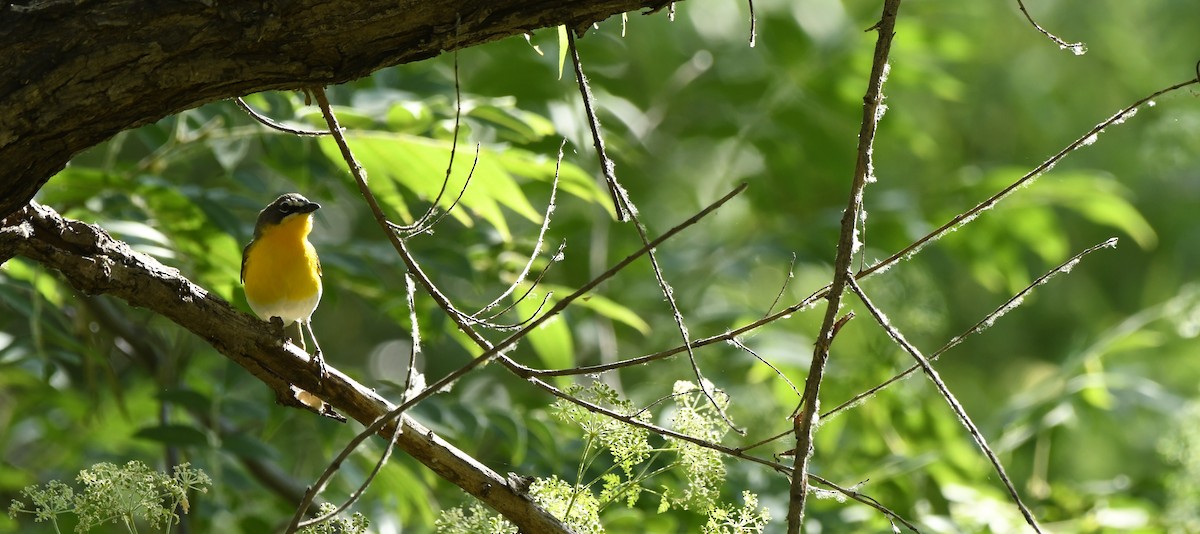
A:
[0,0,1200,533]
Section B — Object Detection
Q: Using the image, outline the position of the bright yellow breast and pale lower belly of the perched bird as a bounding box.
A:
[242,214,322,324]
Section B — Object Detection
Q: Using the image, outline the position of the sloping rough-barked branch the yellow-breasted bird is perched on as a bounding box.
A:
[0,204,569,533]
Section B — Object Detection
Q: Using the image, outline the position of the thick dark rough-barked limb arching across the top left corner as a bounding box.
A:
[0,0,668,217]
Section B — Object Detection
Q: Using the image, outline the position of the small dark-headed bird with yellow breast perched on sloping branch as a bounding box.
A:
[241,193,325,377]
